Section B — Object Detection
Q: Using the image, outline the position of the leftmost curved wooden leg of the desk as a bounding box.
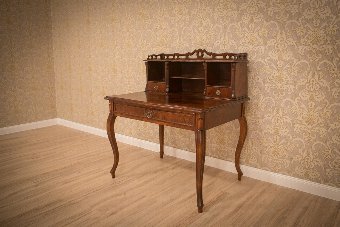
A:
[106,112,119,178]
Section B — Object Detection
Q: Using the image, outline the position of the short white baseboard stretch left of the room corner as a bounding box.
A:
[0,118,57,135]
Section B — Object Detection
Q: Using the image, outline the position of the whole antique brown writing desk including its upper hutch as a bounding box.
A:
[105,49,249,213]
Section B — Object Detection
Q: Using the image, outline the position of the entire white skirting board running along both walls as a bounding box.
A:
[0,118,340,201]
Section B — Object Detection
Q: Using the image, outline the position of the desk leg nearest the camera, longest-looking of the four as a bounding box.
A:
[195,130,206,213]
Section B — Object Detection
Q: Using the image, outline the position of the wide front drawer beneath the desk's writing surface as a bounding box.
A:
[114,103,195,128]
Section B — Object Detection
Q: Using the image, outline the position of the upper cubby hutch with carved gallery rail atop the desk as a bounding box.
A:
[145,49,248,99]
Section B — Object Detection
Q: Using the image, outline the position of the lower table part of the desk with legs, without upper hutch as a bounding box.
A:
[105,92,248,213]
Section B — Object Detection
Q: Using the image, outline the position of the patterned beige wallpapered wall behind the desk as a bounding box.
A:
[51,0,340,187]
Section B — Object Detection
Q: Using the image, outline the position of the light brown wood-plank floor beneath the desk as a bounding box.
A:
[0,126,340,226]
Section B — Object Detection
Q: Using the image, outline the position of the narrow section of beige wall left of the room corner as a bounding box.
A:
[0,0,56,128]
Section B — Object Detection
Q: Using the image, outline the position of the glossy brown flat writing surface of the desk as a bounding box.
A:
[105,92,249,112]
